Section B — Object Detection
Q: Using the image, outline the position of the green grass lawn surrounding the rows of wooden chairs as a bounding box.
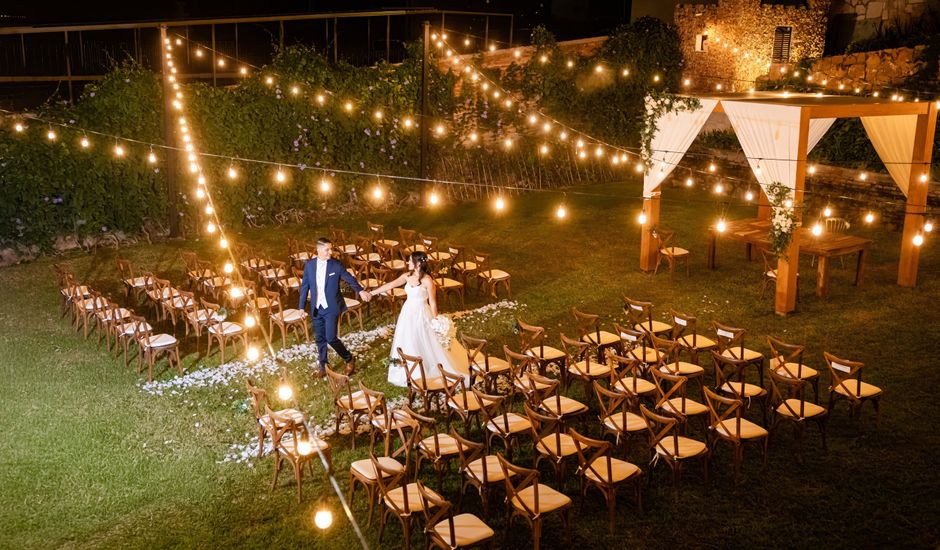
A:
[0,179,940,548]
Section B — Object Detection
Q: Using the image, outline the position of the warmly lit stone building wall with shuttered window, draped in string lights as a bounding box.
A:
[675,0,829,91]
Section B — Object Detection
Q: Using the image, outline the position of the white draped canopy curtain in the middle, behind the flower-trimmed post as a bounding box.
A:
[721,101,836,194]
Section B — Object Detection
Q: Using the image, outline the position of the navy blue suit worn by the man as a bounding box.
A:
[298,258,362,370]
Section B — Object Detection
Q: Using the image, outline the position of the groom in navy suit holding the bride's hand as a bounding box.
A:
[298,237,372,378]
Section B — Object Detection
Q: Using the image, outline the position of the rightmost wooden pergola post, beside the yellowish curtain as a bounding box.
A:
[898,101,937,287]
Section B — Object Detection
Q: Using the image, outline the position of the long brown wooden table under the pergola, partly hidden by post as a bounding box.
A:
[707,218,871,296]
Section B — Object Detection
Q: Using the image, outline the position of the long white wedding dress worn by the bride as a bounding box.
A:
[388,282,463,387]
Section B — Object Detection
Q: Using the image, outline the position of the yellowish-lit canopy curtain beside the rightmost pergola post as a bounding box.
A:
[861,115,917,197]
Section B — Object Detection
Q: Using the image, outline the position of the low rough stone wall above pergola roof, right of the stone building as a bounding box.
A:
[810,46,925,93]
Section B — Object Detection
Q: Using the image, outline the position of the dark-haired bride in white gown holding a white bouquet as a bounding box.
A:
[371,251,456,387]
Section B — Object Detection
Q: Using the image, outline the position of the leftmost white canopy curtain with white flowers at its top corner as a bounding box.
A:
[643,99,718,198]
